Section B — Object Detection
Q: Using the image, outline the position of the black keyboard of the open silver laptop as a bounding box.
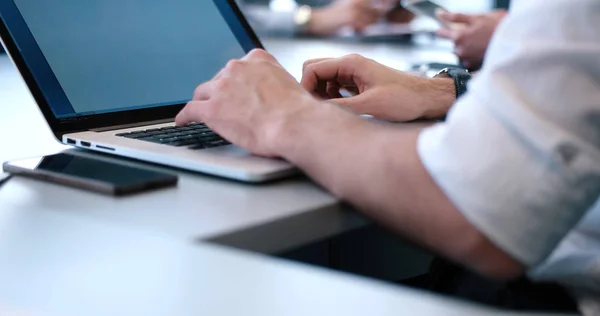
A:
[117,123,231,150]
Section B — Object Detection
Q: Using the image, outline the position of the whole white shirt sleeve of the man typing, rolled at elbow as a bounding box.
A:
[418,0,600,267]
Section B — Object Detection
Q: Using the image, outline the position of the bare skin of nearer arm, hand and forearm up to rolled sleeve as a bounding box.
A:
[176,51,523,277]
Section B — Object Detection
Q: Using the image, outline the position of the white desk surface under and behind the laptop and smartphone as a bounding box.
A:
[0,40,454,252]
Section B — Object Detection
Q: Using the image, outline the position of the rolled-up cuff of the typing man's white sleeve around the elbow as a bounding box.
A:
[419,92,598,266]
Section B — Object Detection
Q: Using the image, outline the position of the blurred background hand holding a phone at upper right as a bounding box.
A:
[436,10,508,70]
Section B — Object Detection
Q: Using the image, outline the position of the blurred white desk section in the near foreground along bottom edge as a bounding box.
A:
[0,210,576,316]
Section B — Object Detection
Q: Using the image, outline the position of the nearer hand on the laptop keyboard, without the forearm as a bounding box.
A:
[176,50,318,157]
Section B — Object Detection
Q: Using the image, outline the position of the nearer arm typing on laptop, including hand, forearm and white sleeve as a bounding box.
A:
[176,0,600,277]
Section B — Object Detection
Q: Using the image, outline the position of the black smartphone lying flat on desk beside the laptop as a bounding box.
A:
[3,153,178,196]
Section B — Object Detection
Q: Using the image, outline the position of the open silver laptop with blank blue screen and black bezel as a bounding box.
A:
[0,0,296,182]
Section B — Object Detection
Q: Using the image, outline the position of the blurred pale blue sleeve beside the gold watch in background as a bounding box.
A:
[236,0,297,37]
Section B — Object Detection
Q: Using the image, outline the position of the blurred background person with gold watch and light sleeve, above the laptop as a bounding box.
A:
[236,0,414,37]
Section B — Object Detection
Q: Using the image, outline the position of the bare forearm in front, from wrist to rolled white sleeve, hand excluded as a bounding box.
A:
[280,105,520,276]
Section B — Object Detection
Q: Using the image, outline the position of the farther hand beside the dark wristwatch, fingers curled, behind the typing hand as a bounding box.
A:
[302,55,456,122]
